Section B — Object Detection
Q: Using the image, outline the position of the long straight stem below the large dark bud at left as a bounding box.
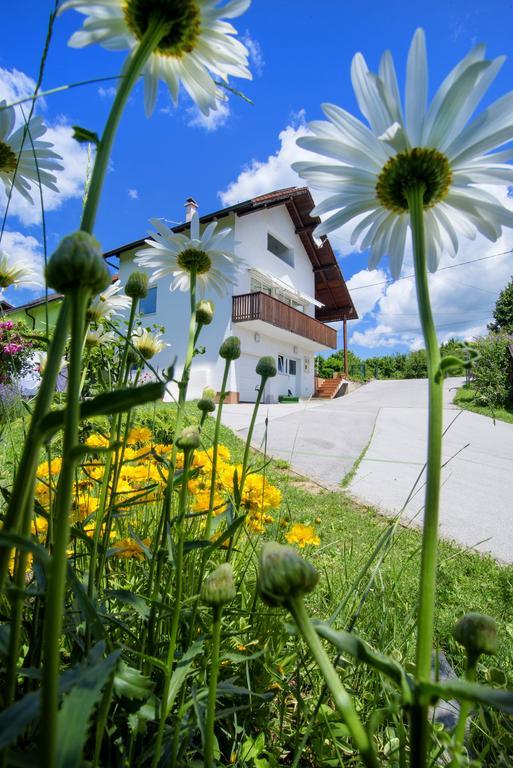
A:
[41,286,89,768]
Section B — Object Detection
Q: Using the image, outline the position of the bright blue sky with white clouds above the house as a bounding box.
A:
[0,0,513,356]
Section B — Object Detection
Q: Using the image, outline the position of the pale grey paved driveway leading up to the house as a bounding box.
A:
[223,379,513,562]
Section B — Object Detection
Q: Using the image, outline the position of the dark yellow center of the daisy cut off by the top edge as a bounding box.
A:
[124,0,201,56]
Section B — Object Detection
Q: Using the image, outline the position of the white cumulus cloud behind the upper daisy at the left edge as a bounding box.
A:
[0,68,88,225]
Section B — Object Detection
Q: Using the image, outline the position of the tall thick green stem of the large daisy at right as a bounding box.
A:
[405,184,443,768]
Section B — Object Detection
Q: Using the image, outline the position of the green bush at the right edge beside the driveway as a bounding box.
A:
[473,333,513,408]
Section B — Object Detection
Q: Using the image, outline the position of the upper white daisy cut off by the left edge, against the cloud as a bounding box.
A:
[0,101,62,203]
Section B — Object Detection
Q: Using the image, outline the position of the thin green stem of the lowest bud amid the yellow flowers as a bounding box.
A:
[152,450,193,768]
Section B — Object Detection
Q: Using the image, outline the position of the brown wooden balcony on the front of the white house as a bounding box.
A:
[232,292,337,349]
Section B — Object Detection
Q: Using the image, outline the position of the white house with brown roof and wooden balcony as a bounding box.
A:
[105,187,358,402]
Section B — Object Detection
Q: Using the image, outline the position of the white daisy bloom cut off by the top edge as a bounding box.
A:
[60,0,251,115]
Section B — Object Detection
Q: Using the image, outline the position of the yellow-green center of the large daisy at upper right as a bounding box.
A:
[376,147,452,213]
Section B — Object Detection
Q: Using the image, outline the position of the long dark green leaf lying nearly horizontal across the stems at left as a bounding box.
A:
[39,382,166,440]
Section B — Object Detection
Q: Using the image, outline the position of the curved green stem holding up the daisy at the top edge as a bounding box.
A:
[80,21,169,232]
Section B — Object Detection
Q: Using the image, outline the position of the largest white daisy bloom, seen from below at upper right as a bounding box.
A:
[292,29,513,278]
